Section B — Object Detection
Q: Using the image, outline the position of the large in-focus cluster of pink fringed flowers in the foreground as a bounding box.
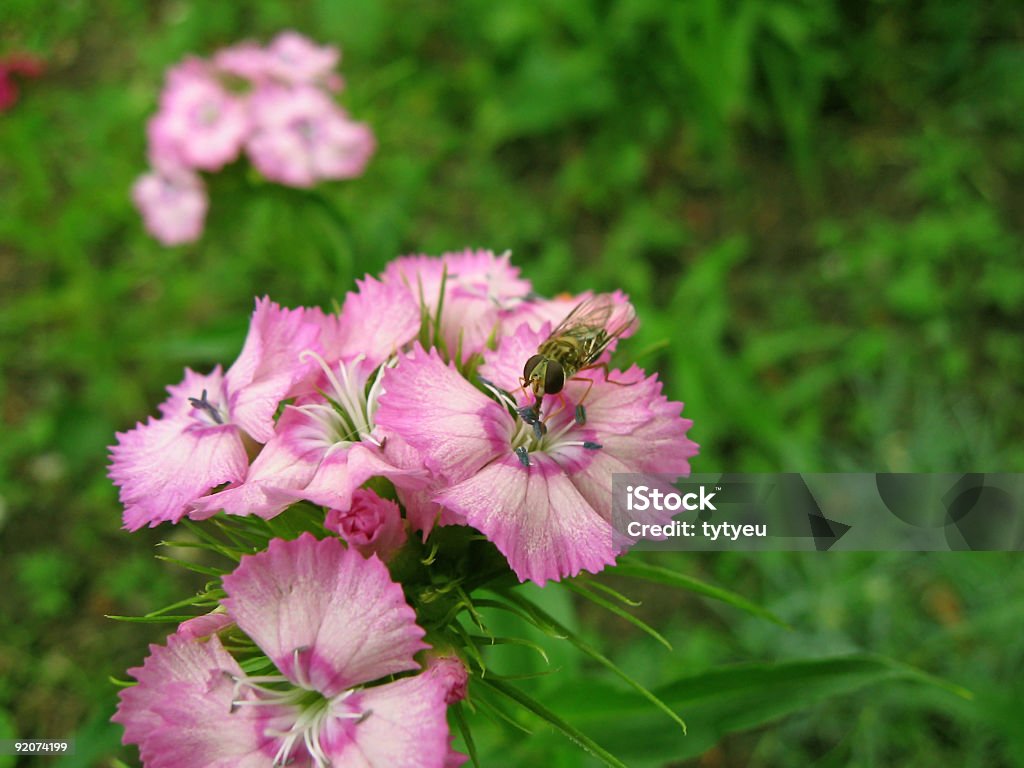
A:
[111,251,697,766]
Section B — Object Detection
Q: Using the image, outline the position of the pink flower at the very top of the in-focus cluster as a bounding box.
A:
[381,249,531,360]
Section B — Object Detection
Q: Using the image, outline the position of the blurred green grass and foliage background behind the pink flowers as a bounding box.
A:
[0,0,1024,768]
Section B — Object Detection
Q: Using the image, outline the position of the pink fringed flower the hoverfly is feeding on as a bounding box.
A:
[377,326,697,585]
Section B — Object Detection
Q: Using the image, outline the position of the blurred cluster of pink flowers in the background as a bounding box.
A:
[132,32,375,245]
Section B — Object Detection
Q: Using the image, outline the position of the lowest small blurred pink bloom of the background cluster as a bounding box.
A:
[131,170,209,246]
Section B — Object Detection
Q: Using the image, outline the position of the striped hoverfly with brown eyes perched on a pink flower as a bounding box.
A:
[519,294,636,433]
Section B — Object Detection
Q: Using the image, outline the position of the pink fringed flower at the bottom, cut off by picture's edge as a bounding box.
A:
[114,534,450,768]
